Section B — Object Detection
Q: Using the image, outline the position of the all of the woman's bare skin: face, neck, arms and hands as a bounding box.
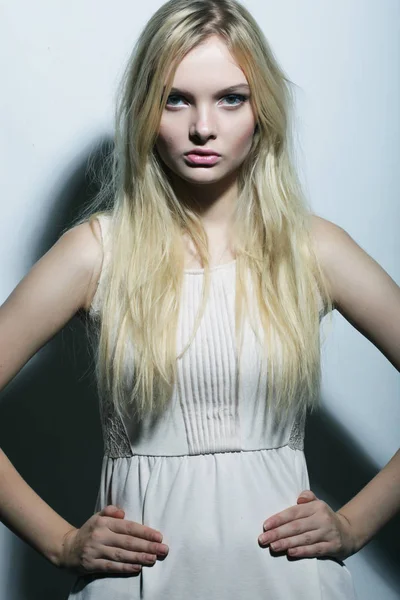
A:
[0,32,400,575]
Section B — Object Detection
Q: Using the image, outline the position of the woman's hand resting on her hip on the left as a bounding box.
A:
[60,505,169,574]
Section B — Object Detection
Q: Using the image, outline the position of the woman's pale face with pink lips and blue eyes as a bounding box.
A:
[156,36,256,184]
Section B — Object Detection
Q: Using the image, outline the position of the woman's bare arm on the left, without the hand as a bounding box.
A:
[0,223,102,564]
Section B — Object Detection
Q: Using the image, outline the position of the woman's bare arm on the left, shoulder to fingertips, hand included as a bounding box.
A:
[0,223,168,575]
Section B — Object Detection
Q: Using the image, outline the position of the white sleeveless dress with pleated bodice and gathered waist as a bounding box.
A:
[69,215,356,600]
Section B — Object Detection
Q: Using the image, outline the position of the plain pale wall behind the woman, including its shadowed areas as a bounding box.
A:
[0,0,400,600]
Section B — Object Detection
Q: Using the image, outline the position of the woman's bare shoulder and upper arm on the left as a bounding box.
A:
[0,222,103,389]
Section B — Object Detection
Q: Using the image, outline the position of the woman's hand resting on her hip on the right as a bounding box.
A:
[258,490,357,560]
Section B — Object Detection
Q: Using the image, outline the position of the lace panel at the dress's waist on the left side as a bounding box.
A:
[100,398,133,458]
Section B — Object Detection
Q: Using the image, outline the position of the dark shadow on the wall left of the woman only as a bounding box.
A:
[0,138,112,600]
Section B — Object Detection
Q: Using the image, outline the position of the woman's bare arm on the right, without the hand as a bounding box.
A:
[314,217,400,550]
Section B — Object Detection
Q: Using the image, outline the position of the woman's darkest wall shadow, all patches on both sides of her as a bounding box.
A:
[0,140,400,600]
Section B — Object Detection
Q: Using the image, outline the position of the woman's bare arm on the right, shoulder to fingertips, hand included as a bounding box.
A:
[259,217,400,559]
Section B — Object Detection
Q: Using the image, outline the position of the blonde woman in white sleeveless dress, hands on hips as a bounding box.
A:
[0,0,400,600]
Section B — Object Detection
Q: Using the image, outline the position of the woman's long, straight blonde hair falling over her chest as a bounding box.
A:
[73,0,332,419]
